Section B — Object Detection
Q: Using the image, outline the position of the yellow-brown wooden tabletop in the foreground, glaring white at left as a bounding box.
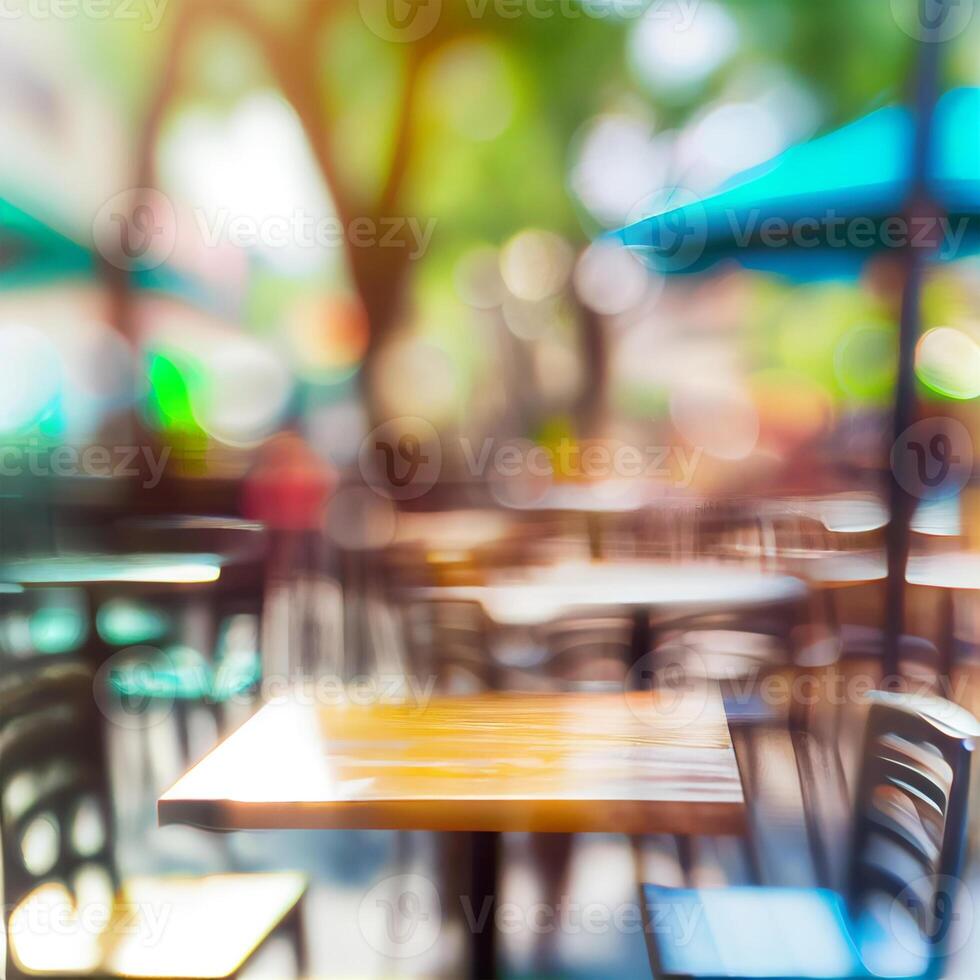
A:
[159,686,744,834]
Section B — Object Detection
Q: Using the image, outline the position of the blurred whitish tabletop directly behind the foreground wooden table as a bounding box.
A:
[412,562,806,626]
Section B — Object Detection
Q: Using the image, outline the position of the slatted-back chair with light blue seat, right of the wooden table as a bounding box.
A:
[643,694,973,980]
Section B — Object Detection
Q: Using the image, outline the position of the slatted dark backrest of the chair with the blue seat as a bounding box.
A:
[847,694,973,960]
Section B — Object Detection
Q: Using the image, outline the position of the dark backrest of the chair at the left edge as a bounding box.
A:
[0,657,118,977]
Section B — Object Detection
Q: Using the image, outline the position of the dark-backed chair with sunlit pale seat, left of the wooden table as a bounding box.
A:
[0,658,306,980]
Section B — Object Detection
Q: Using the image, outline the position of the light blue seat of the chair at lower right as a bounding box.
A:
[643,885,929,980]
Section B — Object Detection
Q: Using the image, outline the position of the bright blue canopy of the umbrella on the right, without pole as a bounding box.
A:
[611,88,980,280]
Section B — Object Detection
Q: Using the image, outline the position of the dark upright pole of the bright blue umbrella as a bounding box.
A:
[883,7,950,687]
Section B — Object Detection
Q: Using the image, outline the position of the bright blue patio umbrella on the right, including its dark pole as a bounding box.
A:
[611,63,980,675]
